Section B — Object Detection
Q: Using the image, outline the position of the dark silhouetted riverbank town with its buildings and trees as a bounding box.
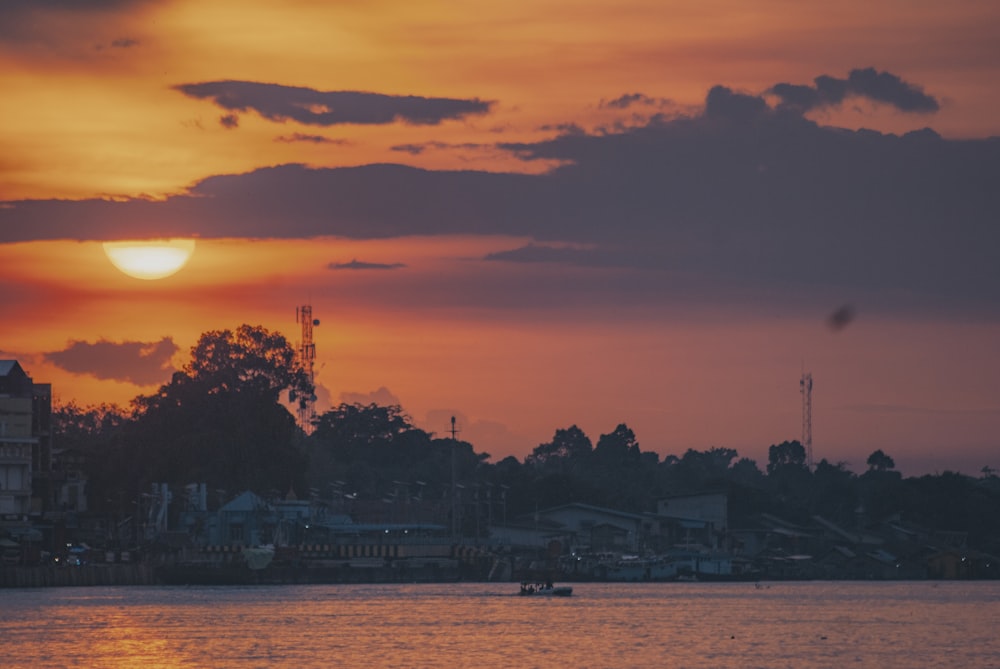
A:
[0,325,1000,586]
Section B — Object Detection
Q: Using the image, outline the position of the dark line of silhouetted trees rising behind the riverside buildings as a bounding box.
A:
[53,325,1000,552]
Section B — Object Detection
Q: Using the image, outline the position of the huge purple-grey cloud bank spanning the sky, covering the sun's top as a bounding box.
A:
[0,77,1000,314]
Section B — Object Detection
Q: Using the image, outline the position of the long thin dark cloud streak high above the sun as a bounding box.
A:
[175,81,492,126]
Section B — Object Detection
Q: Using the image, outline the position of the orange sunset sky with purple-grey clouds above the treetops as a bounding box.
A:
[0,0,1000,476]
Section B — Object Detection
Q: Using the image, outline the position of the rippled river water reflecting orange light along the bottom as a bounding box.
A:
[0,582,1000,669]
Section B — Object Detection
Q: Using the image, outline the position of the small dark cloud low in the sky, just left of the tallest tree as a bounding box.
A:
[44,337,179,386]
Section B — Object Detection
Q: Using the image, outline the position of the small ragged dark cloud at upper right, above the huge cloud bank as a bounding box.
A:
[768,67,939,113]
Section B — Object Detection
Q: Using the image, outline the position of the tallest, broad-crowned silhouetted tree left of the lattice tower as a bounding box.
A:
[128,325,311,493]
